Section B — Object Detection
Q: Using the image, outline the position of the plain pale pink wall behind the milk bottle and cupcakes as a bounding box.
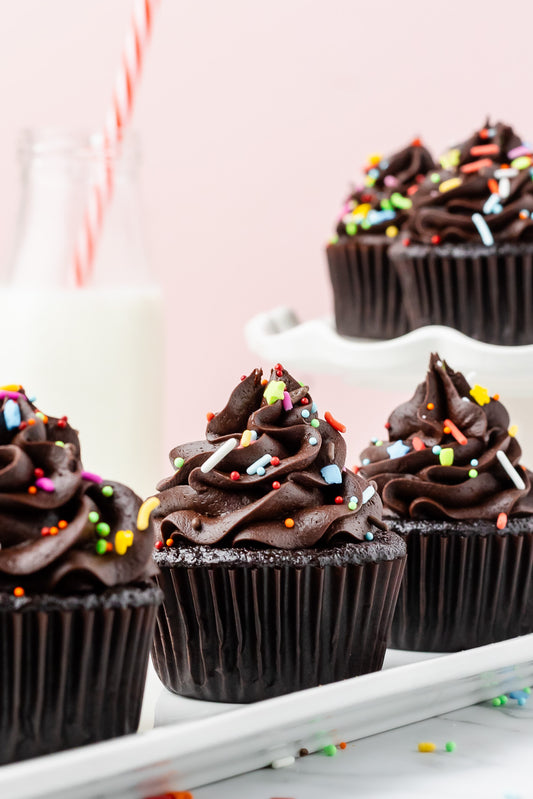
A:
[0,0,533,472]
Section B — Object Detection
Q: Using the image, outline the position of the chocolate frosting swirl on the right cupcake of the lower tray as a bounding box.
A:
[361,354,533,521]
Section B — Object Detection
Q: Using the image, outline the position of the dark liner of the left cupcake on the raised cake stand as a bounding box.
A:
[326,236,411,339]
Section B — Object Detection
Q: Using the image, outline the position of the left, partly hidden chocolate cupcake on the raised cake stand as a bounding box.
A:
[326,139,435,339]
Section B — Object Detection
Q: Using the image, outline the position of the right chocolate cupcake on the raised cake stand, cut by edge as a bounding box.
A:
[390,123,533,345]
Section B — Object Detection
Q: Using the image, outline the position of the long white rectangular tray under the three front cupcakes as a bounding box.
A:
[0,634,533,799]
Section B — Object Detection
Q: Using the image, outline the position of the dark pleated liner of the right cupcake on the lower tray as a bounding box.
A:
[390,519,533,652]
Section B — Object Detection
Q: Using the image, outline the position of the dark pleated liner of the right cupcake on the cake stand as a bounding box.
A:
[390,244,533,346]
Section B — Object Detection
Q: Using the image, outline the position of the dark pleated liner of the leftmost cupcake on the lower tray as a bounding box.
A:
[0,585,161,764]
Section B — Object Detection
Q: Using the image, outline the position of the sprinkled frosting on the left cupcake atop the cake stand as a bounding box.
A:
[336,139,435,237]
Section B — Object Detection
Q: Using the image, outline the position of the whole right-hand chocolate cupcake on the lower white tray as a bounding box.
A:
[361,354,533,652]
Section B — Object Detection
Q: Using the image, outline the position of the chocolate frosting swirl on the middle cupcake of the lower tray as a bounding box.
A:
[153,365,386,549]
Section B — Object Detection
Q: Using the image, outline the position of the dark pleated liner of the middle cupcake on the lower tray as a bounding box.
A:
[152,557,405,702]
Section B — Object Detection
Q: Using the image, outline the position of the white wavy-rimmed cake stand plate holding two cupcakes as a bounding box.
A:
[245,307,533,397]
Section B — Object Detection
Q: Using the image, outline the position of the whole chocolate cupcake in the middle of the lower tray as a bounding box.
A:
[152,364,405,702]
